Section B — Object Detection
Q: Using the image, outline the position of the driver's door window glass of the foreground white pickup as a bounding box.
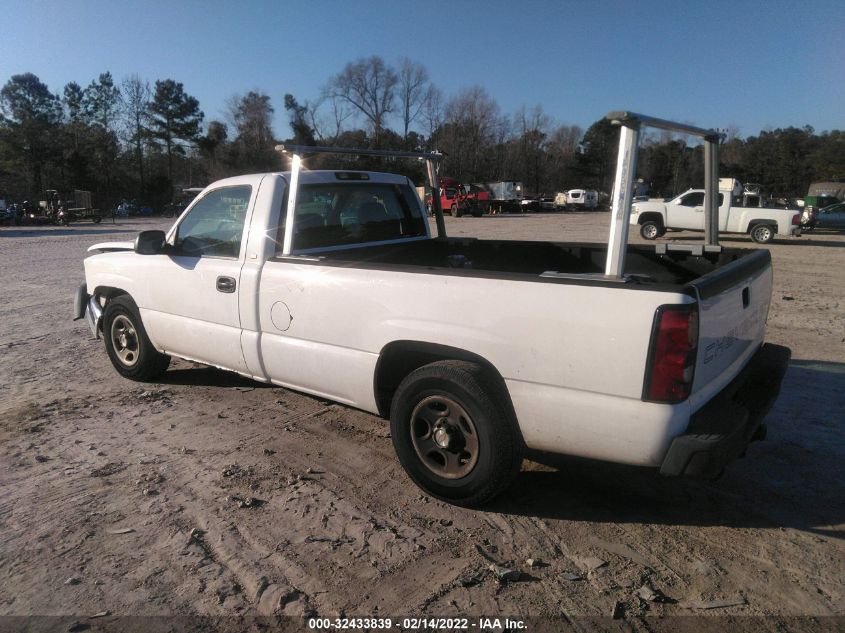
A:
[176,185,252,259]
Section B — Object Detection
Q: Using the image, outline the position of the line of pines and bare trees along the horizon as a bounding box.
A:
[0,56,845,207]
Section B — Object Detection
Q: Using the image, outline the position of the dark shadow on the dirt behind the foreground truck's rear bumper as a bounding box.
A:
[488,361,845,539]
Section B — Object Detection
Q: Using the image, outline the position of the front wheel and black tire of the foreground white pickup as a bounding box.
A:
[103,295,170,381]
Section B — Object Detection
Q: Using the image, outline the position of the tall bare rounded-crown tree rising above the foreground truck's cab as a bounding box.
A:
[326,55,399,145]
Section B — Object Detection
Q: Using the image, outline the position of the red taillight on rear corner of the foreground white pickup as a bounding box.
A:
[643,305,698,403]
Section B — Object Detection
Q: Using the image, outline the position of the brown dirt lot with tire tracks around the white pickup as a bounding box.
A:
[0,213,845,631]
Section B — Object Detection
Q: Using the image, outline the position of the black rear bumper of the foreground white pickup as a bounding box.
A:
[660,343,792,477]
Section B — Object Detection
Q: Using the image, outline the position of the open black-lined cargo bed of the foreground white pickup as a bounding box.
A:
[306,238,755,289]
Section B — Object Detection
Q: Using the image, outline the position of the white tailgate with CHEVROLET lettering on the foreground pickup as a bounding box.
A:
[690,249,772,411]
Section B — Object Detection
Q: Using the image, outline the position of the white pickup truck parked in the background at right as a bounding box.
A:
[631,178,801,244]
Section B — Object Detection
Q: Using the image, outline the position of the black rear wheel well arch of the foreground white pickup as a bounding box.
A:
[373,340,516,422]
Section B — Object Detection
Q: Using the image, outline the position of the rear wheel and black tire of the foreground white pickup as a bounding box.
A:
[390,360,523,507]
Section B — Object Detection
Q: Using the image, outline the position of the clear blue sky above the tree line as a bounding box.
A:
[0,0,845,137]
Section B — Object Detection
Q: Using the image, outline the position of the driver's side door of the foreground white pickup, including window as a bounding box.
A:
[141,180,260,372]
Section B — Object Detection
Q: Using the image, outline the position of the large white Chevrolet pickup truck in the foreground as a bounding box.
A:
[75,132,789,505]
